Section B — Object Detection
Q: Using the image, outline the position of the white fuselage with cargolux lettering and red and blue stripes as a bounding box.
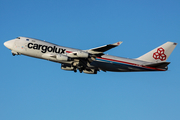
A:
[4,37,167,72]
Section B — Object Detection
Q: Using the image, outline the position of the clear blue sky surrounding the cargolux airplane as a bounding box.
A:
[0,0,180,120]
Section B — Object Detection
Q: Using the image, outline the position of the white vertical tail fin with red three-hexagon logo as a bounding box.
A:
[137,42,177,63]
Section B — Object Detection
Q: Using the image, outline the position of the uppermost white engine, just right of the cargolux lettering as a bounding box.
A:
[68,51,89,58]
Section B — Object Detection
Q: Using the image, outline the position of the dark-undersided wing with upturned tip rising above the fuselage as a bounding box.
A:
[86,41,122,54]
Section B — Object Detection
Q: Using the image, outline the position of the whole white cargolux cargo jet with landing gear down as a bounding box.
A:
[4,37,177,74]
